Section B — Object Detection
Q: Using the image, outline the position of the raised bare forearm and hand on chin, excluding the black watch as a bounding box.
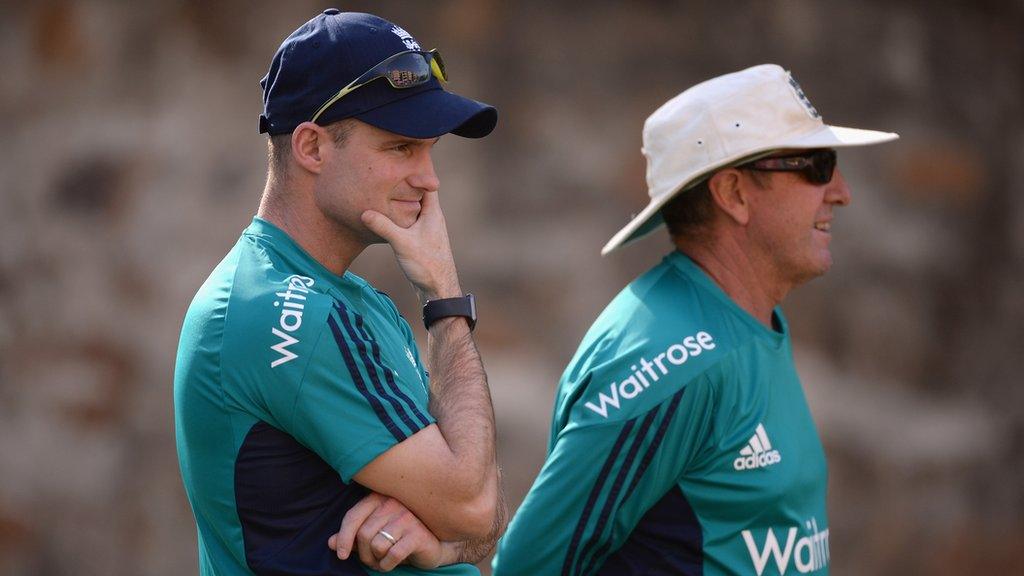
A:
[354,196,499,541]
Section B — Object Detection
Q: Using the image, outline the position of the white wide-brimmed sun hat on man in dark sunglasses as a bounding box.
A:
[601,64,899,255]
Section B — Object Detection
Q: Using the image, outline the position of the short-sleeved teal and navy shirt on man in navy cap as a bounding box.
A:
[174,218,479,576]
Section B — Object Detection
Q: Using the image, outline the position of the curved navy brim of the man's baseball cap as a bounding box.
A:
[353,87,498,138]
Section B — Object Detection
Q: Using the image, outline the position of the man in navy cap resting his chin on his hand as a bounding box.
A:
[174,9,505,575]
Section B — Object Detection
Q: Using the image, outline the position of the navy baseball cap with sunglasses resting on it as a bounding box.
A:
[259,8,498,138]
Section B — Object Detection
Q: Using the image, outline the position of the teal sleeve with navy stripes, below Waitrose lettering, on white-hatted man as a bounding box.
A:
[494,368,714,576]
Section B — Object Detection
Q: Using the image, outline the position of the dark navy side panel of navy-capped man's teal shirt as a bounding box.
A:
[234,422,369,576]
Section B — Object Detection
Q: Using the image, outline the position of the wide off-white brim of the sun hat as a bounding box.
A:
[601,126,899,256]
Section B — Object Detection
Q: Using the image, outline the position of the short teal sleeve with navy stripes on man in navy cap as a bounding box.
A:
[290,305,434,482]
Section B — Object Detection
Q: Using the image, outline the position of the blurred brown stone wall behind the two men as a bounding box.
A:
[0,0,1024,576]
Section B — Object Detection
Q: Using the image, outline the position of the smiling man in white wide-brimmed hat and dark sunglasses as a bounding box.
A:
[495,65,897,576]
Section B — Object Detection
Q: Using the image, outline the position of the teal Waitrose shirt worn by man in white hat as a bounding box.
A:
[494,252,828,576]
